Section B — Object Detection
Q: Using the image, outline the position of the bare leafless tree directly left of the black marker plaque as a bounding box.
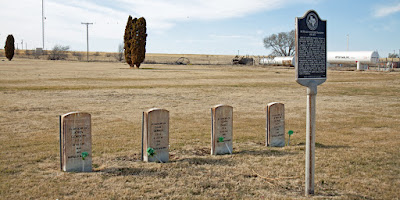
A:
[264,30,295,56]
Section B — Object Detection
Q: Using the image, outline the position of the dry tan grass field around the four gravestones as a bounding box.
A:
[0,57,400,199]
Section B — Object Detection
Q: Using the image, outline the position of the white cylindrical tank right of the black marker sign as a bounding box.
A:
[327,51,379,65]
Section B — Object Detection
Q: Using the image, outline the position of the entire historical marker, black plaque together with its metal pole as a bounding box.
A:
[295,10,326,196]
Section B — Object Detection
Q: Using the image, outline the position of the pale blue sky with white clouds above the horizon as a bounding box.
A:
[0,0,400,57]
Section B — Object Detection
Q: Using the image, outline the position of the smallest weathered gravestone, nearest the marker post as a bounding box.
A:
[265,102,285,147]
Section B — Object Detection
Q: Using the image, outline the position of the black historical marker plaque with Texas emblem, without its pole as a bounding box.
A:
[295,10,327,86]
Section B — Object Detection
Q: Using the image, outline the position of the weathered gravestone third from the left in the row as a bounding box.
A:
[211,105,233,155]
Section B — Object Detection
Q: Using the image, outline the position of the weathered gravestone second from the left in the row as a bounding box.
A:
[142,108,169,163]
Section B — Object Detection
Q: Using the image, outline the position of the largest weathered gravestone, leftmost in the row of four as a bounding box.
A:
[60,112,92,172]
